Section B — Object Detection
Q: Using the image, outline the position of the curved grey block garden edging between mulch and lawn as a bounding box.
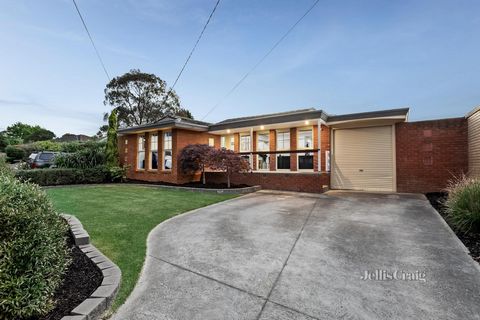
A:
[62,214,122,320]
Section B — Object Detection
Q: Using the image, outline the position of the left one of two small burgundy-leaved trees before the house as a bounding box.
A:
[180,144,214,184]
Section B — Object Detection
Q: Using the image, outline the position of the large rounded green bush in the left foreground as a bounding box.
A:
[0,170,69,319]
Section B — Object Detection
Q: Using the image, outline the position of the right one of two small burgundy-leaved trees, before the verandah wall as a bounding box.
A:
[209,148,250,188]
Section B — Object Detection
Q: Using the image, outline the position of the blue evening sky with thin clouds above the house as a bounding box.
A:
[0,0,480,135]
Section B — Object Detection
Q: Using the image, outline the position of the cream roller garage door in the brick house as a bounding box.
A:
[332,126,395,191]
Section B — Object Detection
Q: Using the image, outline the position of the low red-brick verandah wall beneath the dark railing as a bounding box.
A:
[206,172,330,193]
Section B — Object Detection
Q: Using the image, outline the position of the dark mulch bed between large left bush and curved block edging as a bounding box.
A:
[31,232,103,320]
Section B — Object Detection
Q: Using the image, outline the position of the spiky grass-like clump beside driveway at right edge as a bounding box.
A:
[445,176,480,233]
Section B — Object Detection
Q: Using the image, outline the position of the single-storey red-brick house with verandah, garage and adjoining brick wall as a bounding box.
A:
[119,108,474,192]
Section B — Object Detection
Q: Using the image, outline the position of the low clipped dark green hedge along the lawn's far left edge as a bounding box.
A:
[15,166,112,186]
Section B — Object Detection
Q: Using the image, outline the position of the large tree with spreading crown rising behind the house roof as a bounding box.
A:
[104,69,191,127]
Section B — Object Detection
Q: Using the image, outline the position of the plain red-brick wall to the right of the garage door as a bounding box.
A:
[395,118,468,193]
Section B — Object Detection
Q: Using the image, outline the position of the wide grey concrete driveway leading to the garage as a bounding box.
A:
[114,192,480,320]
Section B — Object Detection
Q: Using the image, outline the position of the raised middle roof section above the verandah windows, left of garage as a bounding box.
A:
[209,108,327,131]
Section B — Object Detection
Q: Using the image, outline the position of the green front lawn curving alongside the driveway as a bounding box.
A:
[46,185,235,310]
